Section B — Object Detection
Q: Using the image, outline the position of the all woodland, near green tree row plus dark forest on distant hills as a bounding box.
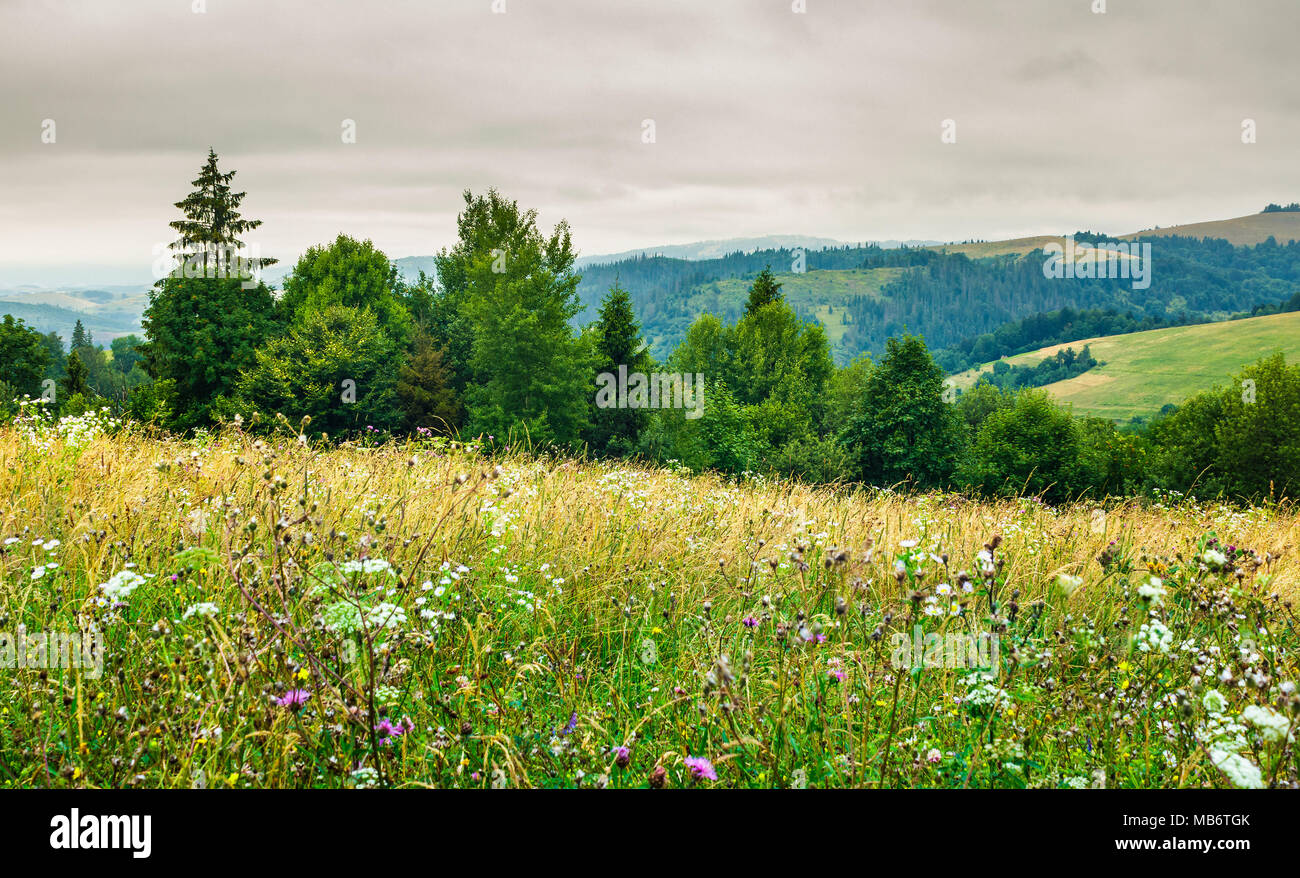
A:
[0,153,1300,502]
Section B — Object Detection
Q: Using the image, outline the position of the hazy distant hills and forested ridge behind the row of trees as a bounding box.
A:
[0,211,1300,372]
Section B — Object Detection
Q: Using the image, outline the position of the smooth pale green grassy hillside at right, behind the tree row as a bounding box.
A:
[953,312,1300,420]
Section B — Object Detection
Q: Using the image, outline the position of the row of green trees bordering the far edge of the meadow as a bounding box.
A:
[0,153,1300,502]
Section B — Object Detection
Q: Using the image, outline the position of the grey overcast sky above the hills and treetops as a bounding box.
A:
[0,0,1300,284]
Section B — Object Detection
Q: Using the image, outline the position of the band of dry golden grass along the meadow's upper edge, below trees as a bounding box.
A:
[0,432,1300,619]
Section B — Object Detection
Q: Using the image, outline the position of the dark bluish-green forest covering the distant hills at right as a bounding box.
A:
[579,232,1300,372]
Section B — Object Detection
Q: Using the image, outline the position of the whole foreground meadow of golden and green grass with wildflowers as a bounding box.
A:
[0,421,1300,788]
